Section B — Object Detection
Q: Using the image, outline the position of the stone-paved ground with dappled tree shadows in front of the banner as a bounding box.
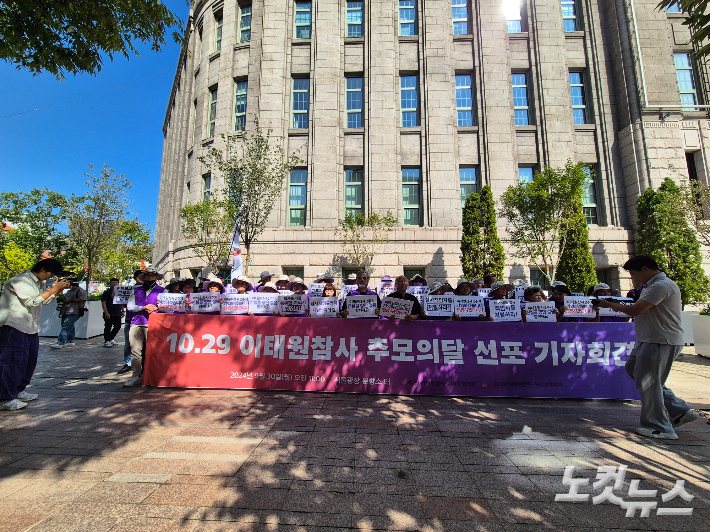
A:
[0,335,710,532]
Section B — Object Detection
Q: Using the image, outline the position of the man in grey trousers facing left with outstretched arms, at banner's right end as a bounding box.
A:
[598,255,700,440]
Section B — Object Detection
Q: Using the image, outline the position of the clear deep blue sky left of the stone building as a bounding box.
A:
[0,0,188,233]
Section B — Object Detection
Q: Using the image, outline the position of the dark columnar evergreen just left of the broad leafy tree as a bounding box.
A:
[460,185,505,279]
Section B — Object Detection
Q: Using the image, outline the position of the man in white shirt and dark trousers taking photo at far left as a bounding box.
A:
[0,259,69,410]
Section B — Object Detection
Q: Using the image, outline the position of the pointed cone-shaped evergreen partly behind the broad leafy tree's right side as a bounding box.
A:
[555,198,598,294]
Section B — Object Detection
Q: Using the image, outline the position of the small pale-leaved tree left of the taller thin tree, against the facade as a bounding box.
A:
[180,199,234,273]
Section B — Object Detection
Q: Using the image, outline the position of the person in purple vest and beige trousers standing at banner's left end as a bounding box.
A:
[123,268,165,387]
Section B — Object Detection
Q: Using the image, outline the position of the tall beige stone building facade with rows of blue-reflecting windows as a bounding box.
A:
[153,0,710,289]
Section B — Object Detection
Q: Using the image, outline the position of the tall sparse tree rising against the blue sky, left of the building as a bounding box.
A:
[69,164,131,290]
